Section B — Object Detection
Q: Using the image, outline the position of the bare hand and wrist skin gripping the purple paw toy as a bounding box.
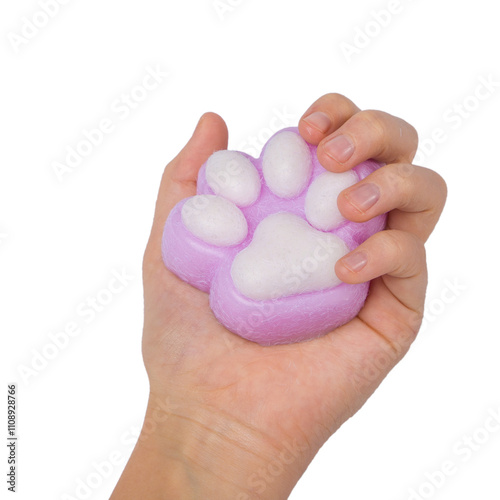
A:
[111,94,446,500]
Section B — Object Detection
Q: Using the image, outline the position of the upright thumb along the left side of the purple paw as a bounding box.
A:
[148,113,228,258]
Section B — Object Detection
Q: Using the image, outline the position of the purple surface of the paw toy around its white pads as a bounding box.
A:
[162,128,386,345]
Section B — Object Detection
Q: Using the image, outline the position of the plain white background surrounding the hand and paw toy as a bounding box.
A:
[0,0,500,500]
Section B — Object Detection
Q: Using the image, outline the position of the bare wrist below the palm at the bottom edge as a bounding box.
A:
[133,394,313,500]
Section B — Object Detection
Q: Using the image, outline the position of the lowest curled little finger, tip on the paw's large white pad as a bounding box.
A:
[335,230,427,312]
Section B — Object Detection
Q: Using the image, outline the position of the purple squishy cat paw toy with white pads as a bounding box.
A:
[162,128,386,345]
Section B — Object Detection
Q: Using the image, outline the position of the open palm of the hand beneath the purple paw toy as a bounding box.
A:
[143,254,416,451]
